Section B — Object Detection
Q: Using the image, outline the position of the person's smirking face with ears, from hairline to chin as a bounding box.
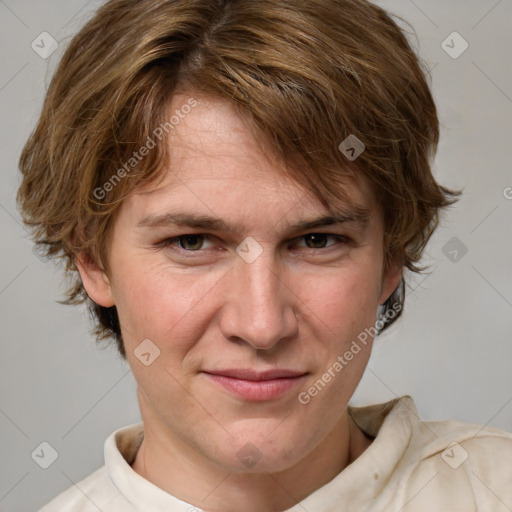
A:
[81,95,400,472]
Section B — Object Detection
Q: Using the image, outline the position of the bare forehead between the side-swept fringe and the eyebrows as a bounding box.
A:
[123,93,375,228]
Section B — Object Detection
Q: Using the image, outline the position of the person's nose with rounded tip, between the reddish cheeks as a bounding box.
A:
[220,251,299,350]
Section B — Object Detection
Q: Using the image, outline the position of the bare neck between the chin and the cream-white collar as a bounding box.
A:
[132,400,371,512]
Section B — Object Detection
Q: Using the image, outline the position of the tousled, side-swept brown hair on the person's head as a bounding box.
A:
[17,0,457,357]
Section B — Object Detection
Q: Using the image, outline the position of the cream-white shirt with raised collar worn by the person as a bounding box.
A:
[39,396,512,512]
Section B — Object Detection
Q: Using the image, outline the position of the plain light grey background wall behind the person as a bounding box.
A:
[0,0,512,512]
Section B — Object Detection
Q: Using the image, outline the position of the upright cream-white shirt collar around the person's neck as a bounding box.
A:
[104,396,420,512]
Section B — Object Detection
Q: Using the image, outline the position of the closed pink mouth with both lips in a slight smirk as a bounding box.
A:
[202,369,308,402]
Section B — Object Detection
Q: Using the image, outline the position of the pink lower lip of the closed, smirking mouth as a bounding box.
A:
[205,373,305,402]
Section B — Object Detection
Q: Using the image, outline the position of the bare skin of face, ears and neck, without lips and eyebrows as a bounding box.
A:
[78,94,401,512]
